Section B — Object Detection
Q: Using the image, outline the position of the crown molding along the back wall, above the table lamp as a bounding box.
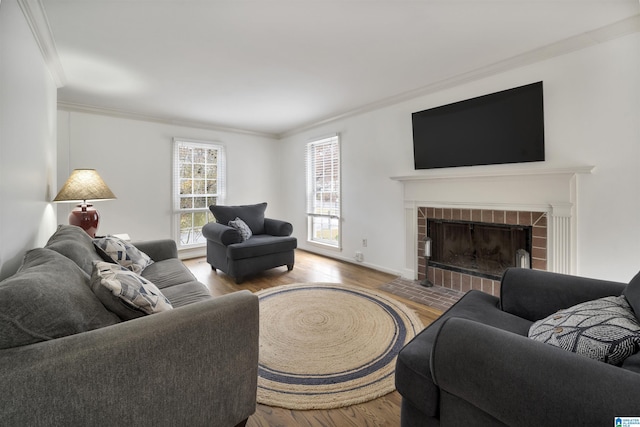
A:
[58,101,278,139]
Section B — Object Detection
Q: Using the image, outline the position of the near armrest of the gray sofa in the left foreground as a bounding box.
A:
[0,291,259,426]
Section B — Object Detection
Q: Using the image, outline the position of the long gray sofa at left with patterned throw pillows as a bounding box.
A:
[0,226,258,427]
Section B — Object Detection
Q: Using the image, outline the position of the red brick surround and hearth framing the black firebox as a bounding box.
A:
[416,206,547,296]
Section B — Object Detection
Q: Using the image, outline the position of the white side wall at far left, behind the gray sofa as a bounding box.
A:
[0,0,57,279]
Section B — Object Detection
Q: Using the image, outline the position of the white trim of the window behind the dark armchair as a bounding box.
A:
[171,137,227,250]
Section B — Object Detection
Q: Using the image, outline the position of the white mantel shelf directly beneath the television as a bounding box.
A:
[391,164,595,182]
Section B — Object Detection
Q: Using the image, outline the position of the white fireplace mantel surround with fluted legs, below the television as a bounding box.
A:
[391,163,595,279]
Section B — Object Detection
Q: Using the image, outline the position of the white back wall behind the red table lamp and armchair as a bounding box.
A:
[58,110,286,249]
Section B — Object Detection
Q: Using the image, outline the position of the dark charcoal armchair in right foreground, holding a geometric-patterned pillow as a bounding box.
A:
[396,269,640,427]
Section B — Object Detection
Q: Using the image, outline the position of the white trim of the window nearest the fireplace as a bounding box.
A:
[305,134,342,251]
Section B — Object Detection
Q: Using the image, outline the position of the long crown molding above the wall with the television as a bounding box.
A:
[278,14,640,139]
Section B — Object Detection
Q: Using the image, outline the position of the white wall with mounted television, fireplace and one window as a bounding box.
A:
[280,33,640,281]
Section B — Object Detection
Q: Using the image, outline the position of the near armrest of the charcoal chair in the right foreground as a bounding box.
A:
[431,318,640,427]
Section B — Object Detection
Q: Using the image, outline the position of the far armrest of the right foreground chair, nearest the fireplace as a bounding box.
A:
[500,268,626,322]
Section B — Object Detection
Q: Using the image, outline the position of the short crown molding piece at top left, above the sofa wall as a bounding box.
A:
[18,0,67,88]
